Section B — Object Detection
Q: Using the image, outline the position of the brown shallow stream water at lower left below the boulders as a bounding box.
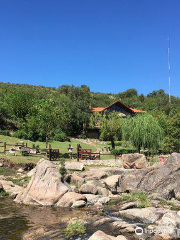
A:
[0,198,89,240]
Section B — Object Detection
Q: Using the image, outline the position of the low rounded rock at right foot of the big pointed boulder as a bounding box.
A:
[56,192,87,207]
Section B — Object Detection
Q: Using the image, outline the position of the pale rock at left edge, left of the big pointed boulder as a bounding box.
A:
[0,180,24,198]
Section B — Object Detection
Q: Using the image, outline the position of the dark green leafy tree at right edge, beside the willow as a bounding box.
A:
[163,114,180,153]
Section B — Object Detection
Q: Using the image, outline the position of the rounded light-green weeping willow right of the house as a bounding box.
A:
[122,115,163,152]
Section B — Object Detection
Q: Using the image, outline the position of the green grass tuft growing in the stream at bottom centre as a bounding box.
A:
[64,221,86,238]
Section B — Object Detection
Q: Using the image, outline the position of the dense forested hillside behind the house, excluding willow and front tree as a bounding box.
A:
[0,82,180,151]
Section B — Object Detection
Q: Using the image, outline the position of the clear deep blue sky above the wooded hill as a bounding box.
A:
[0,0,180,97]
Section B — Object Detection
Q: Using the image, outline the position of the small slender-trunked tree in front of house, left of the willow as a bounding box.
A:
[94,112,122,149]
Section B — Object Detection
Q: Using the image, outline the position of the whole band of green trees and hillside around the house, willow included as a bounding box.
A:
[0,83,180,155]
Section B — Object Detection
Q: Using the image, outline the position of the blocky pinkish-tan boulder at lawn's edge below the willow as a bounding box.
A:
[122,153,147,169]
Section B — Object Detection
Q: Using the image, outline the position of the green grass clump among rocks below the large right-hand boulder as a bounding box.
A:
[121,192,151,208]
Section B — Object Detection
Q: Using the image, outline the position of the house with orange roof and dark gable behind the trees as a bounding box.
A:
[88,100,145,139]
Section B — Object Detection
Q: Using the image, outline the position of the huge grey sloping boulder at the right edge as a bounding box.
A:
[118,153,180,199]
